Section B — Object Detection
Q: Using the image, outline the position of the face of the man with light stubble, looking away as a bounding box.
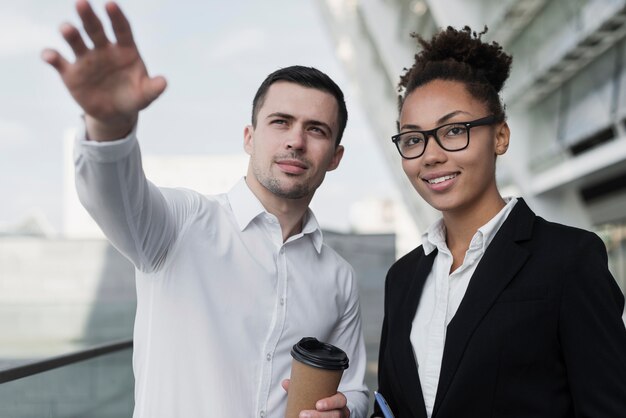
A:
[244,81,343,201]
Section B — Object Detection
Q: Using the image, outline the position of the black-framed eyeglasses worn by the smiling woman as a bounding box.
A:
[391,115,496,160]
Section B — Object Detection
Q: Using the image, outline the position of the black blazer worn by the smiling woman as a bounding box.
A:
[374,199,626,418]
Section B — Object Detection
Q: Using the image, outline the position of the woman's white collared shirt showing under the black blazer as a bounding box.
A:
[410,198,517,418]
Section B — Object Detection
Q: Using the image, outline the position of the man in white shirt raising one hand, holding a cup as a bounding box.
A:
[42,0,367,418]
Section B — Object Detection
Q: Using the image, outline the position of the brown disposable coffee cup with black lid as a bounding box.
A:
[285,337,349,418]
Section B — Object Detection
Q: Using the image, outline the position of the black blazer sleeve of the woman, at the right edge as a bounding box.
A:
[559,233,626,417]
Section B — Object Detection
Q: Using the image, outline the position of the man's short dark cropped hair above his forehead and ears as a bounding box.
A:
[252,65,348,146]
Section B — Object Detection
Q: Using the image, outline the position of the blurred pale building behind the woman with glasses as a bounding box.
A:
[319,0,626,289]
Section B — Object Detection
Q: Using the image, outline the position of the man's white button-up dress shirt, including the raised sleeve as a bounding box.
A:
[75,126,368,418]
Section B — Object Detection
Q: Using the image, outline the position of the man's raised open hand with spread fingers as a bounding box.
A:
[42,0,166,141]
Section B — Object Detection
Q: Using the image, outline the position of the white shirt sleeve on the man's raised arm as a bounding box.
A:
[74,122,176,272]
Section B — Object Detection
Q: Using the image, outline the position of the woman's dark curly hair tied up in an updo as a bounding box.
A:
[398,26,513,122]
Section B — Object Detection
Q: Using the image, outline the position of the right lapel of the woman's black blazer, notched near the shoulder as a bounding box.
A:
[433,199,535,417]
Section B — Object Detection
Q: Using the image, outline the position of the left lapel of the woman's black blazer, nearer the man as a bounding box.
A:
[393,250,437,418]
